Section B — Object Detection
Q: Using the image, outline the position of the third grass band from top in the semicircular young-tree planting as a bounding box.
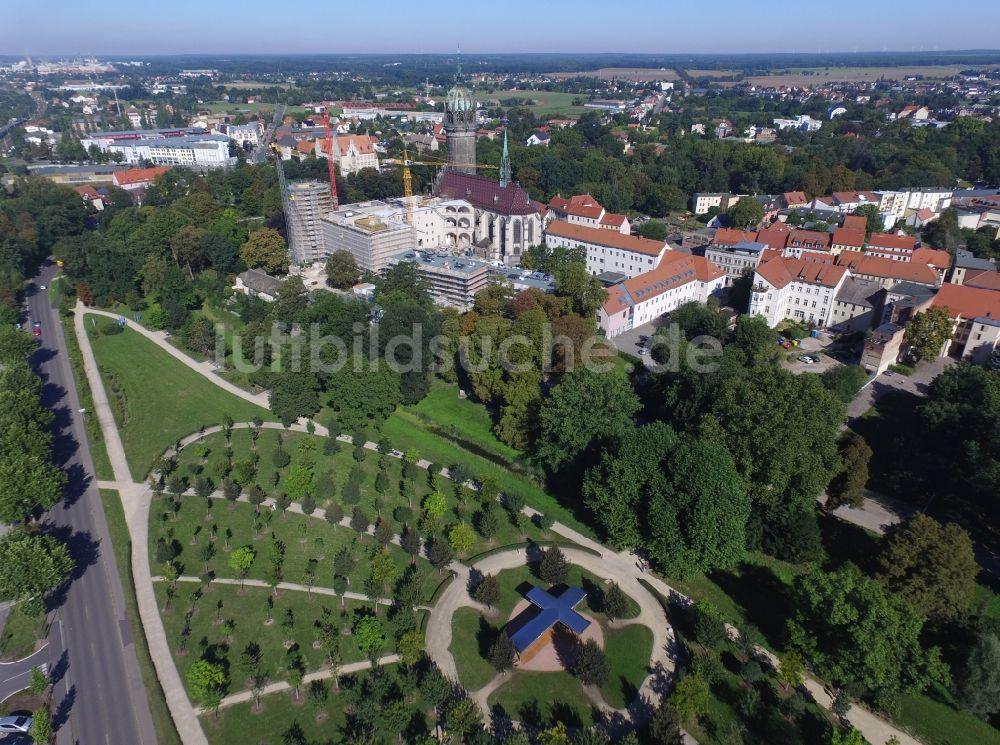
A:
[153,582,376,694]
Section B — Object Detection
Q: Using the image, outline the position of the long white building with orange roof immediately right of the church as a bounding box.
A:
[545,220,670,278]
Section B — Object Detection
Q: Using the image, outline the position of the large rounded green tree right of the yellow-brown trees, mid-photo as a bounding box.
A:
[536,368,640,470]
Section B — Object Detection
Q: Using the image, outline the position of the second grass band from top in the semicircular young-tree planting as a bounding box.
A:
[149,496,441,598]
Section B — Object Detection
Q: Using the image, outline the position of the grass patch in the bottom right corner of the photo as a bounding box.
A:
[895,689,1000,745]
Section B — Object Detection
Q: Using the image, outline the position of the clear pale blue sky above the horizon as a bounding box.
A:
[0,0,1000,56]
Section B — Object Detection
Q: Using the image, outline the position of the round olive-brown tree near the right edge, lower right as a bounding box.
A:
[879,512,979,621]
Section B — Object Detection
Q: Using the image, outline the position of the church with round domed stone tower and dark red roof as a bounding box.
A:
[434,75,543,266]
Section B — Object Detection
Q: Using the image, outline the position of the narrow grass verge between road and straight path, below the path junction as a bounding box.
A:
[101,489,181,745]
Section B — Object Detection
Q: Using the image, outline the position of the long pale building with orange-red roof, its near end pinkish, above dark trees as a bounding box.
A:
[598,252,726,338]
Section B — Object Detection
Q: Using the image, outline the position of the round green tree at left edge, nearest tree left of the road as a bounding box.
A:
[0,528,74,616]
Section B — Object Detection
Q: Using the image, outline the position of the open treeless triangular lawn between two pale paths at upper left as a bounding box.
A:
[86,316,274,481]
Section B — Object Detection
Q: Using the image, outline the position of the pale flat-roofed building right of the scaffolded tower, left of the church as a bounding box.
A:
[322,202,416,273]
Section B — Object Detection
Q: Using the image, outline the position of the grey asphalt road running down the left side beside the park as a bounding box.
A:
[27,264,156,745]
